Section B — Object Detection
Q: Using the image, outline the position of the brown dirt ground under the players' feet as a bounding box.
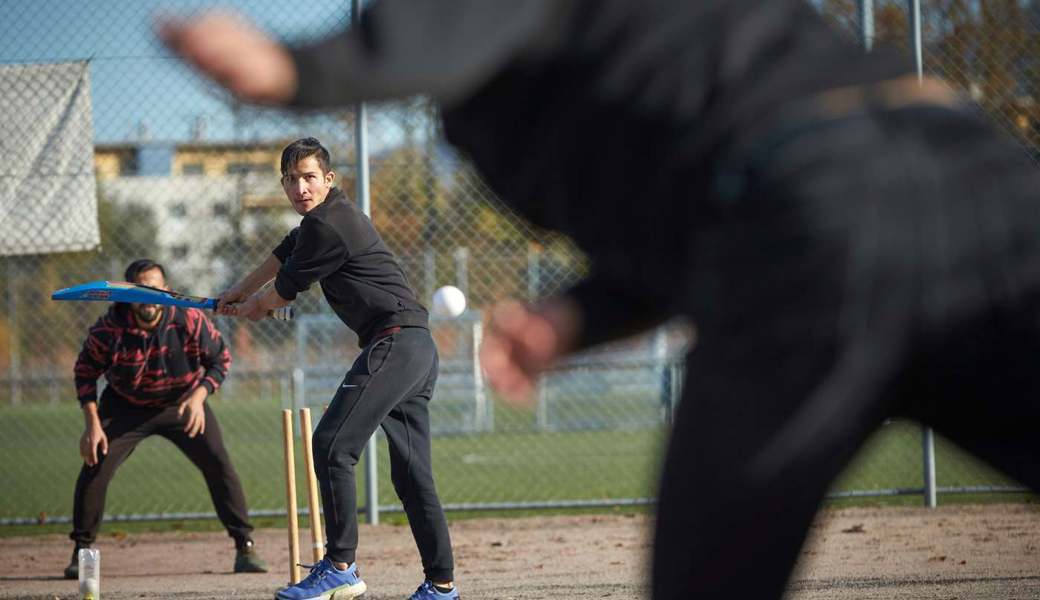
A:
[0,504,1040,600]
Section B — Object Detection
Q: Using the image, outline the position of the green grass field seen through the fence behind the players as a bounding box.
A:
[0,396,1014,534]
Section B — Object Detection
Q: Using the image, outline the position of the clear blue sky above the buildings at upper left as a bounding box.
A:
[0,0,349,144]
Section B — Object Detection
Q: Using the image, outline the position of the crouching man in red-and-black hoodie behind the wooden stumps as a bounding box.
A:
[64,259,267,579]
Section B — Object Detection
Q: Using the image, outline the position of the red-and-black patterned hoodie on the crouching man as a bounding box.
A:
[75,304,231,407]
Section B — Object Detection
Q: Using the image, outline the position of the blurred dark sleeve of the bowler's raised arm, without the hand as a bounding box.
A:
[292,0,576,108]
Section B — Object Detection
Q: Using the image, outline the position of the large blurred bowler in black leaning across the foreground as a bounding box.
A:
[160,0,1040,600]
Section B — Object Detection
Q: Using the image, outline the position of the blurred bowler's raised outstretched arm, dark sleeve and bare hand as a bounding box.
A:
[158,0,576,107]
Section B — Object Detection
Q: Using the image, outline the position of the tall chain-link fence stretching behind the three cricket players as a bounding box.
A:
[0,0,1040,523]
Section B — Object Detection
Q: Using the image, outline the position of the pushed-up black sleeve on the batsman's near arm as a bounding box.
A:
[275,217,349,301]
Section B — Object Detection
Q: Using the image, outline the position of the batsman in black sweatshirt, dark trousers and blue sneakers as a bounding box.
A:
[217,137,459,600]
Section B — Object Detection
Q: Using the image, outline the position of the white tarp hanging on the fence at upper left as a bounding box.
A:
[0,61,101,256]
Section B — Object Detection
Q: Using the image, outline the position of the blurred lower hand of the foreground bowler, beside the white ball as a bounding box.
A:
[480,298,580,405]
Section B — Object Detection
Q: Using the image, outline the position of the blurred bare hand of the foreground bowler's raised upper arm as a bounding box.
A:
[156,11,297,104]
